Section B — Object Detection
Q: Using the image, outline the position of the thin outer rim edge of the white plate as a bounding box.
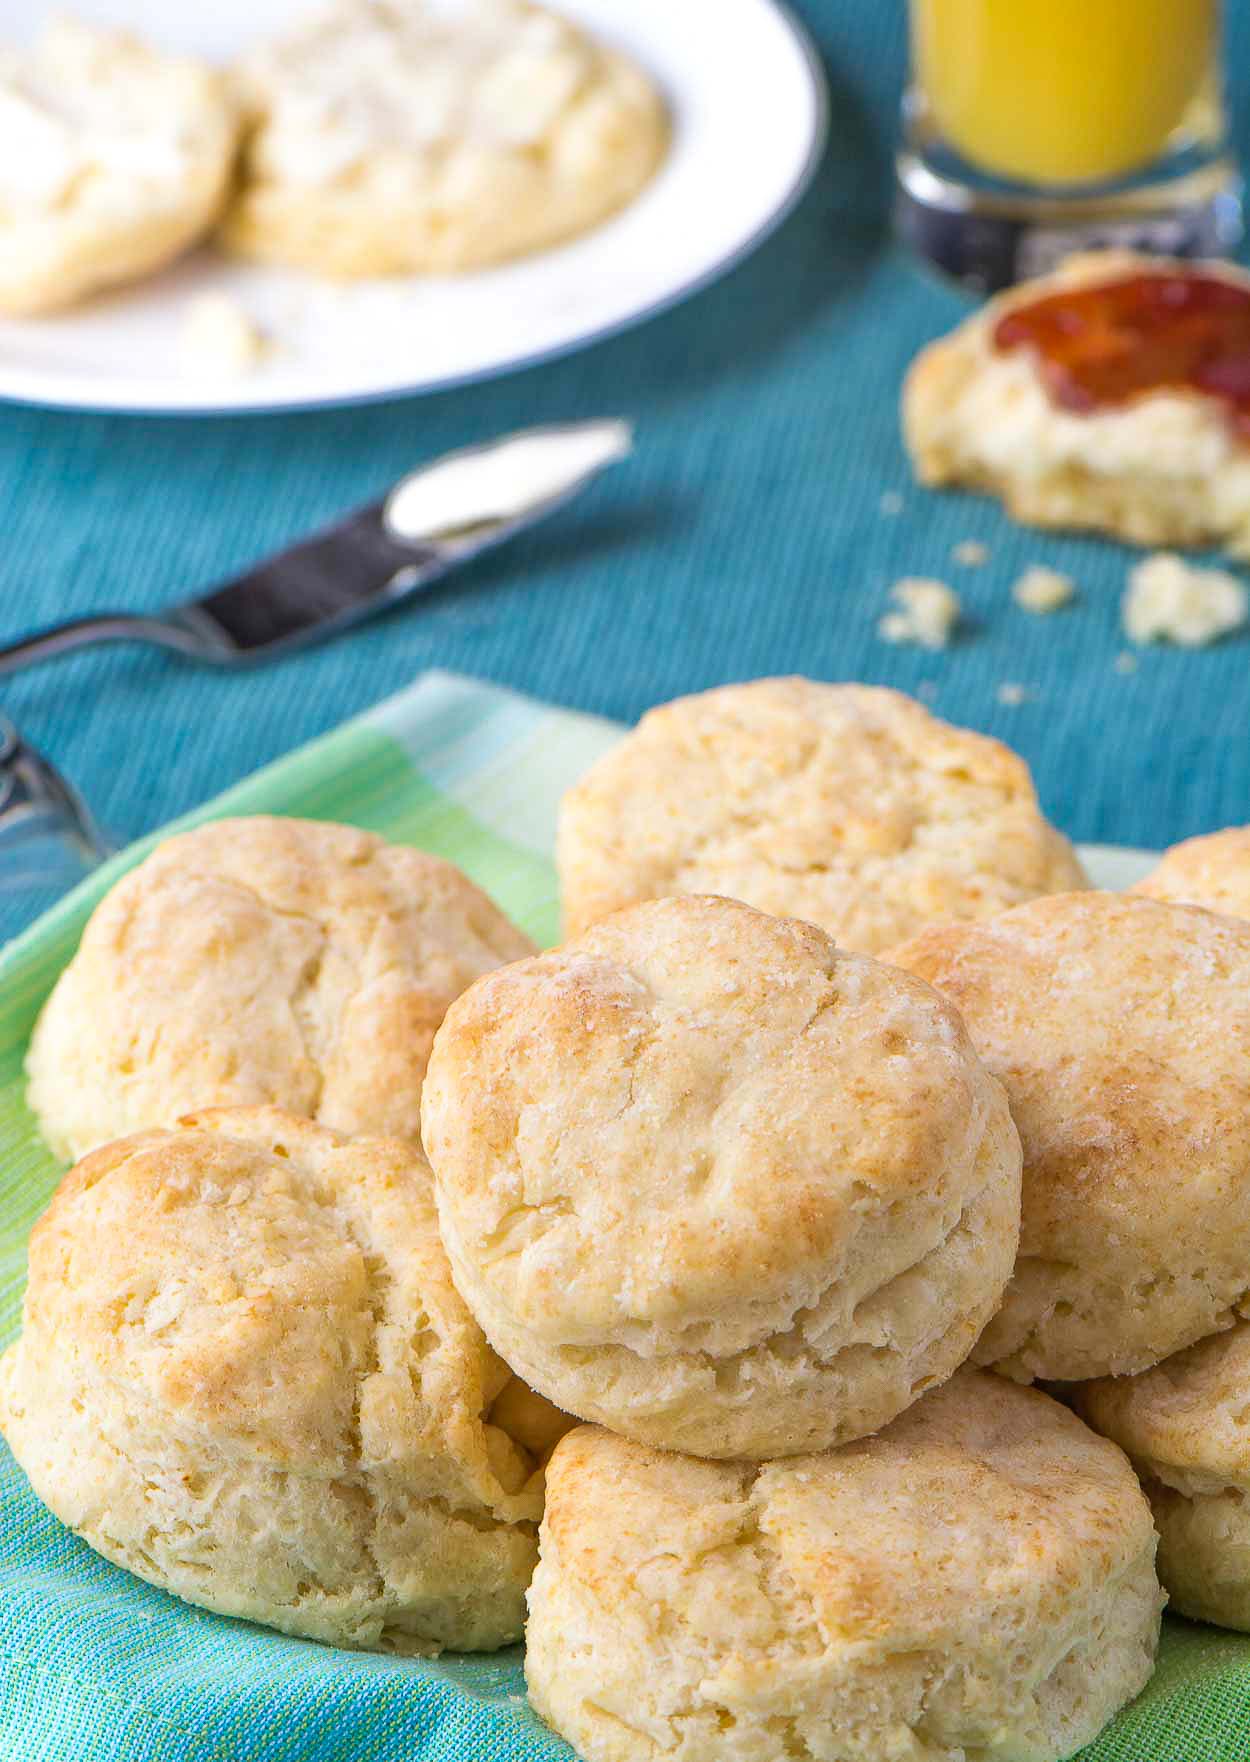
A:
[0,0,830,419]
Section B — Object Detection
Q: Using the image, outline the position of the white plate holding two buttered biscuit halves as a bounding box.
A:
[0,0,825,414]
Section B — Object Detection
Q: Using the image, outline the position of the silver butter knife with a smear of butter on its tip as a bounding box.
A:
[0,421,633,677]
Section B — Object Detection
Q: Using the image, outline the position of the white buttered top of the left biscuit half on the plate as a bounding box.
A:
[0,18,227,218]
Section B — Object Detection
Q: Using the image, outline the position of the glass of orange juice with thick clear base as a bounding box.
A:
[897,0,1241,289]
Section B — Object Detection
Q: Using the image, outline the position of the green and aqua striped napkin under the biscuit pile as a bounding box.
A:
[0,673,1250,1762]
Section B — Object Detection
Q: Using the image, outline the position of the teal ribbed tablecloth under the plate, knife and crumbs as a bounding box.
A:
[0,0,1250,936]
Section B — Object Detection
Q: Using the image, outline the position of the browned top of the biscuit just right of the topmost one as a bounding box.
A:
[896,892,1250,1233]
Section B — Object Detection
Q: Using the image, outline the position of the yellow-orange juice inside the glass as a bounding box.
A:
[911,0,1218,187]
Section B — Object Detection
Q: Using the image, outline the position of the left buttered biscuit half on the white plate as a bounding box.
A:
[0,19,238,315]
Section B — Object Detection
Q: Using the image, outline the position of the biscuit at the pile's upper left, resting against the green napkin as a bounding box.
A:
[26,818,532,1158]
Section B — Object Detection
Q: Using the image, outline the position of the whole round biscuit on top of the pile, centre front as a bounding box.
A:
[423,899,1019,1457]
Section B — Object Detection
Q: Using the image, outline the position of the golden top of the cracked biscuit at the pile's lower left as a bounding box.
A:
[21,1108,550,1521]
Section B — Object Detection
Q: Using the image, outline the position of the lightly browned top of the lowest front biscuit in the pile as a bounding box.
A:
[543,1369,1153,1649]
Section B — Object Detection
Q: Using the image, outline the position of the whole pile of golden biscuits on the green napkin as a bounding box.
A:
[0,680,1250,1762]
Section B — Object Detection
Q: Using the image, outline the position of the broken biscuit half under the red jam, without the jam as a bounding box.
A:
[903,250,1250,557]
